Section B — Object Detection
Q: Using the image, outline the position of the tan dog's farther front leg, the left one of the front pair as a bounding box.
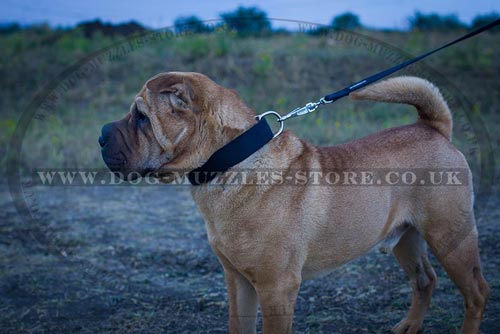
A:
[224,267,257,334]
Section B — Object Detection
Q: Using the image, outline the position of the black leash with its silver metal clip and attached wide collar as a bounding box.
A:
[188,19,500,186]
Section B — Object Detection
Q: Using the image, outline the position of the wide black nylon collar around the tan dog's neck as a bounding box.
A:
[188,118,274,186]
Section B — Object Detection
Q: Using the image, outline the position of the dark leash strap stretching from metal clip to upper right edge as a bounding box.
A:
[322,19,500,103]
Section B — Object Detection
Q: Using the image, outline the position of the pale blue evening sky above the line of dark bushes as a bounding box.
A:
[0,0,500,29]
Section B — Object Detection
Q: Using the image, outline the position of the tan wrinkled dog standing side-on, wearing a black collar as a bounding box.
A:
[99,72,489,334]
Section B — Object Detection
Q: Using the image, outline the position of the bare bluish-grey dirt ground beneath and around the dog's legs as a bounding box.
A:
[0,186,500,334]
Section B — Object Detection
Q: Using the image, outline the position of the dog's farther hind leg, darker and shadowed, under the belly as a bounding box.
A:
[392,227,437,334]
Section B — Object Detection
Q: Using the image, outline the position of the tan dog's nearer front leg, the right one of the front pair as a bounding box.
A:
[256,278,300,334]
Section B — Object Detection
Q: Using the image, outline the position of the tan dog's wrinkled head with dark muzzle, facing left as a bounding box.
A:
[99,72,255,182]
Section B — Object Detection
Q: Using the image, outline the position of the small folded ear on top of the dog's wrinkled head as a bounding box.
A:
[146,72,193,103]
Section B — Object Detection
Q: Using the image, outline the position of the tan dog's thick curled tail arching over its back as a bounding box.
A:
[350,76,453,140]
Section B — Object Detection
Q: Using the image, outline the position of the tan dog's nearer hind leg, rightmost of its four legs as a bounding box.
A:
[425,209,489,334]
